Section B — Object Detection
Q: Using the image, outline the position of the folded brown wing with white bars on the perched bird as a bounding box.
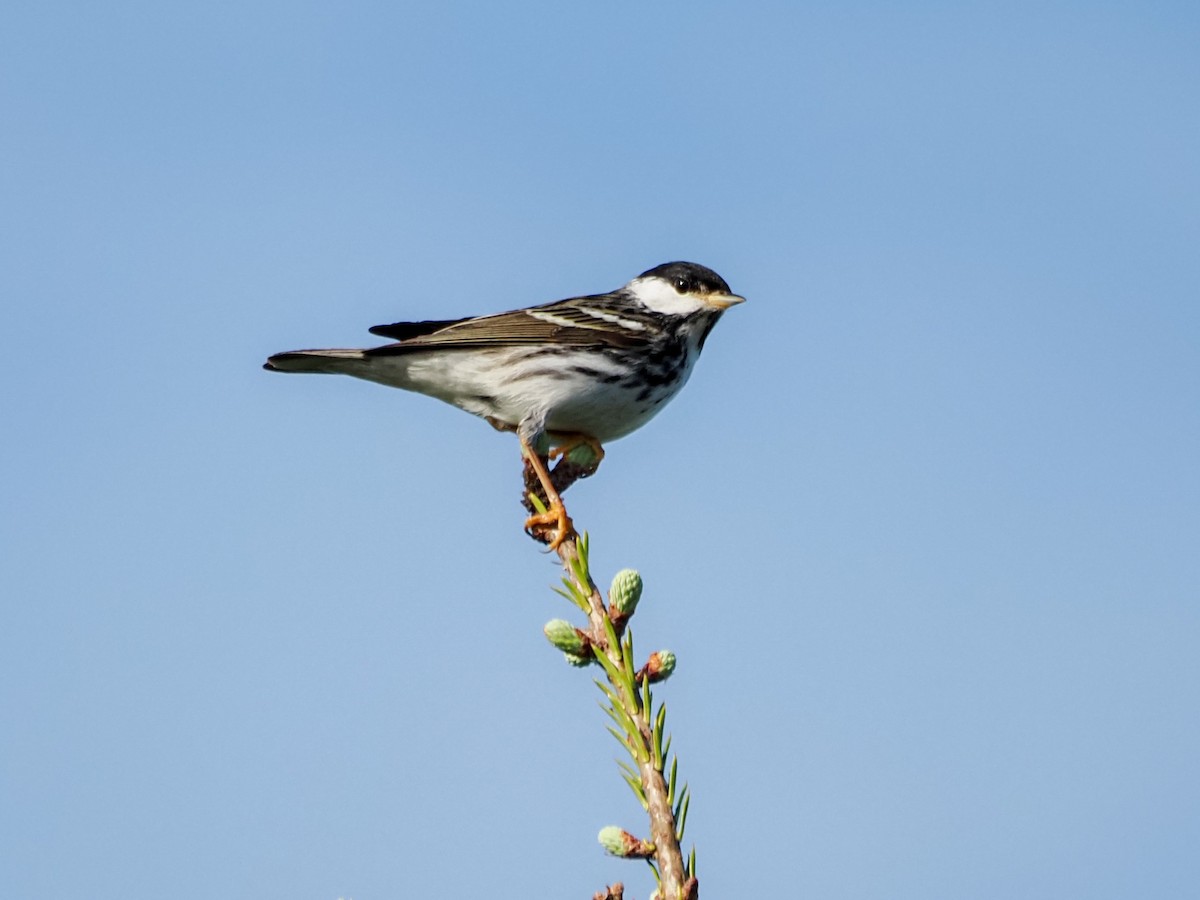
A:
[371,294,659,355]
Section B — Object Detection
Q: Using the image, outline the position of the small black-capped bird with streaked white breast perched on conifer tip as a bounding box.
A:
[264,256,745,550]
